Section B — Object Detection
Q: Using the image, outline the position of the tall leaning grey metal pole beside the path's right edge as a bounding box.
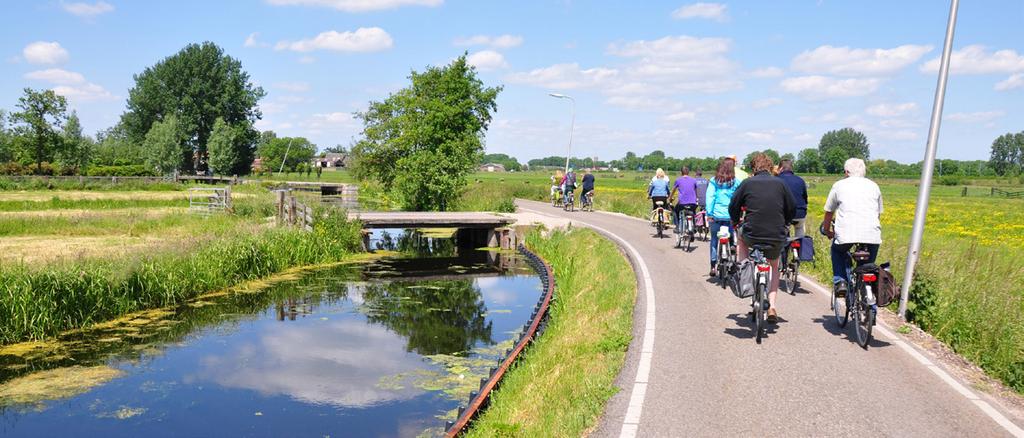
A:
[899,0,959,319]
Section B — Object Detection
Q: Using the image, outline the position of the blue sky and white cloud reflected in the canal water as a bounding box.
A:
[0,257,540,437]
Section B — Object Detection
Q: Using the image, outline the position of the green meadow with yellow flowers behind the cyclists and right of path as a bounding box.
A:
[464,168,1024,392]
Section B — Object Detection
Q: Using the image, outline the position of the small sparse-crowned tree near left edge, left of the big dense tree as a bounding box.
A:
[12,88,68,172]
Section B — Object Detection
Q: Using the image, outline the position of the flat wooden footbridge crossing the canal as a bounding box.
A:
[348,212,516,249]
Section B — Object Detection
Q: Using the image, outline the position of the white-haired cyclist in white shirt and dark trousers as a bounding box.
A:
[821,159,882,297]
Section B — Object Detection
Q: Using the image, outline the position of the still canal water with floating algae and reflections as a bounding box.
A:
[0,230,542,437]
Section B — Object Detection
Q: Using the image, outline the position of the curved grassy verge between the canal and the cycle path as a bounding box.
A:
[469,229,636,437]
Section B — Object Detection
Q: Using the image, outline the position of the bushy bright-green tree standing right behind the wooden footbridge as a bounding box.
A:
[353,54,502,211]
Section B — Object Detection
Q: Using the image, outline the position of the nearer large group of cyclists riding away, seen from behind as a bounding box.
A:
[647,154,882,322]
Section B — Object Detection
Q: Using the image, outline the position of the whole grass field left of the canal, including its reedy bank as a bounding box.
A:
[0,181,359,344]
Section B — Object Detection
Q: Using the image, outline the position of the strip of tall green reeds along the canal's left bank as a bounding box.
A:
[0,209,359,344]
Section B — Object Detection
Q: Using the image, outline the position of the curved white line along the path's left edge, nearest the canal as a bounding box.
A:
[520,207,655,438]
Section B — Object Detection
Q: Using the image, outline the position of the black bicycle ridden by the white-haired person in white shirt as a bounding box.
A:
[831,244,880,350]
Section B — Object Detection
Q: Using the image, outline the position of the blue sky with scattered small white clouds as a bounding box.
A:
[0,0,1024,162]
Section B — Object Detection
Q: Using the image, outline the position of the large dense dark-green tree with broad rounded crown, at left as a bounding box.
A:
[121,42,265,172]
